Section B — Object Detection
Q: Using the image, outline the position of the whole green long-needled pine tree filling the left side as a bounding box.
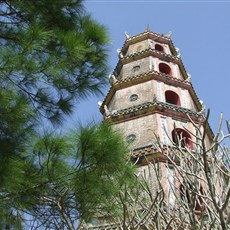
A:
[0,0,136,229]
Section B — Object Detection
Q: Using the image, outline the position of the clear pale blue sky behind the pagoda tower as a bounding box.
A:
[68,0,230,132]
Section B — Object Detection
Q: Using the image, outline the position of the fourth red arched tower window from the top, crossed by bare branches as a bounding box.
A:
[172,128,193,149]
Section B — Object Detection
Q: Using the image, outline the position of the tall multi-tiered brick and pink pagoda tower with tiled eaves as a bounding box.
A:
[93,28,213,228]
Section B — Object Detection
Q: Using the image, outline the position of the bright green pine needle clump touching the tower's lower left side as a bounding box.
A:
[27,123,134,228]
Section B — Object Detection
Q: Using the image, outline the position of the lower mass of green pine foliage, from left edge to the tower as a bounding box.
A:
[0,117,134,229]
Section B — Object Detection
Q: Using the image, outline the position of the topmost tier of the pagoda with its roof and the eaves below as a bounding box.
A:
[113,29,189,80]
